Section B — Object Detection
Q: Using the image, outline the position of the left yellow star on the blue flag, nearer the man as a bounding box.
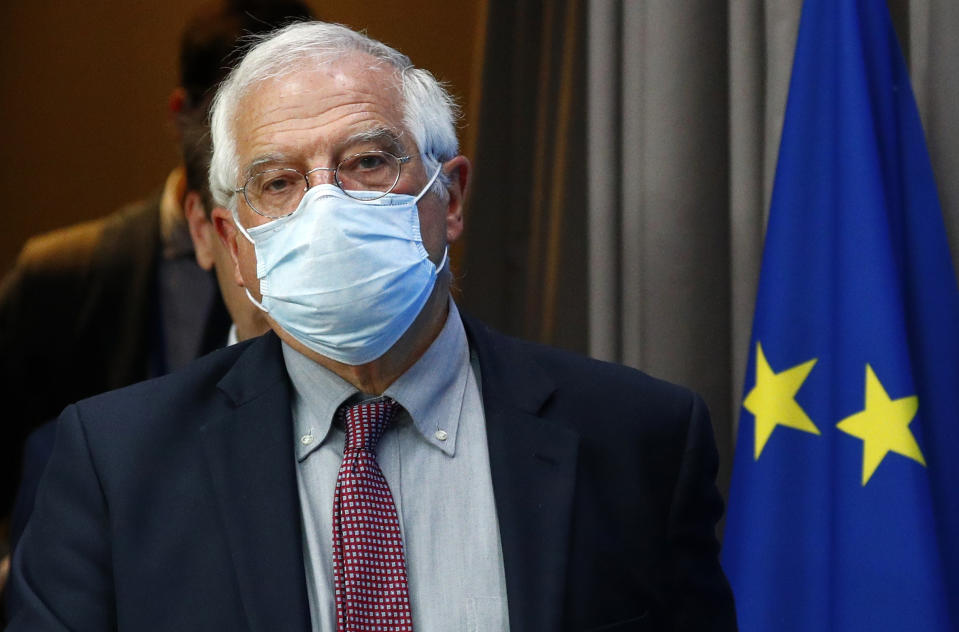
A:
[743,342,819,461]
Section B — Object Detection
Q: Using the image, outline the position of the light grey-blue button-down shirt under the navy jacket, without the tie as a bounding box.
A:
[283,300,509,632]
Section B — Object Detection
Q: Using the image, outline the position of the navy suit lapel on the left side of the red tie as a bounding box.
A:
[202,333,310,632]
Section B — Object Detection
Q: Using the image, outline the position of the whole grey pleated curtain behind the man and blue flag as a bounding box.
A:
[459,0,959,498]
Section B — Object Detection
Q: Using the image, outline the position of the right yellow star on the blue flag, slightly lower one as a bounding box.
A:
[836,364,926,487]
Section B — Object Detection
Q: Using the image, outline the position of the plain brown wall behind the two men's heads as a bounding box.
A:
[0,0,485,273]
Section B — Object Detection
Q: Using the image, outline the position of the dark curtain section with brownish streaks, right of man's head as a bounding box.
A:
[454,0,588,353]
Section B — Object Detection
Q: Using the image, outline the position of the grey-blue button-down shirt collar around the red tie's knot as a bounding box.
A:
[282,299,470,461]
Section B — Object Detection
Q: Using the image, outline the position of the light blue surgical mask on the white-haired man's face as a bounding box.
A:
[234,168,449,365]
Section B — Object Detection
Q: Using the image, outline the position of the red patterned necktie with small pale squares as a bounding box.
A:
[333,397,413,632]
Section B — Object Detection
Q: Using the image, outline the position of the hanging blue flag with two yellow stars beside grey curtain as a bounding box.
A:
[723,0,959,632]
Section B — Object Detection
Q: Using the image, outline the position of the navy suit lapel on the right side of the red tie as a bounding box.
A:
[464,318,579,632]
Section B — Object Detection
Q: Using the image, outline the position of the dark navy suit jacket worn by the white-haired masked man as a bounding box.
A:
[9,320,735,632]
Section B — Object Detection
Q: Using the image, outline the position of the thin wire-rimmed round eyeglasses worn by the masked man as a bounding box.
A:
[233,151,410,219]
